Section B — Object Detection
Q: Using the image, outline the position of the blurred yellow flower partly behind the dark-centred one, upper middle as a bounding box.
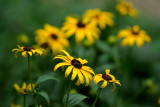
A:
[83,9,114,29]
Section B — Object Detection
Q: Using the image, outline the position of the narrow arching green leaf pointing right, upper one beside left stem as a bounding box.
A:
[35,75,58,86]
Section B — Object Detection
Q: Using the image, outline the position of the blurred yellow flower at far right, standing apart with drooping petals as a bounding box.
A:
[117,25,151,47]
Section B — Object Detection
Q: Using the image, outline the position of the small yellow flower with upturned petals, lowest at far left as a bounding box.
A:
[13,82,35,94]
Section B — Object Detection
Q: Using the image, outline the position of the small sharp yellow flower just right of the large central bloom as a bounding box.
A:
[93,69,121,90]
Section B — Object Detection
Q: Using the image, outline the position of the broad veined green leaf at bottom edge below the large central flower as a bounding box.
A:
[63,93,88,107]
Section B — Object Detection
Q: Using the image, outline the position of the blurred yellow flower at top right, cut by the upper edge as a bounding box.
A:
[116,0,137,16]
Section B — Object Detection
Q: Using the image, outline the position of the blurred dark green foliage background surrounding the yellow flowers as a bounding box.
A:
[0,0,160,107]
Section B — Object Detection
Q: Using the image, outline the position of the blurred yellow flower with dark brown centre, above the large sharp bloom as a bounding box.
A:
[62,16,100,43]
